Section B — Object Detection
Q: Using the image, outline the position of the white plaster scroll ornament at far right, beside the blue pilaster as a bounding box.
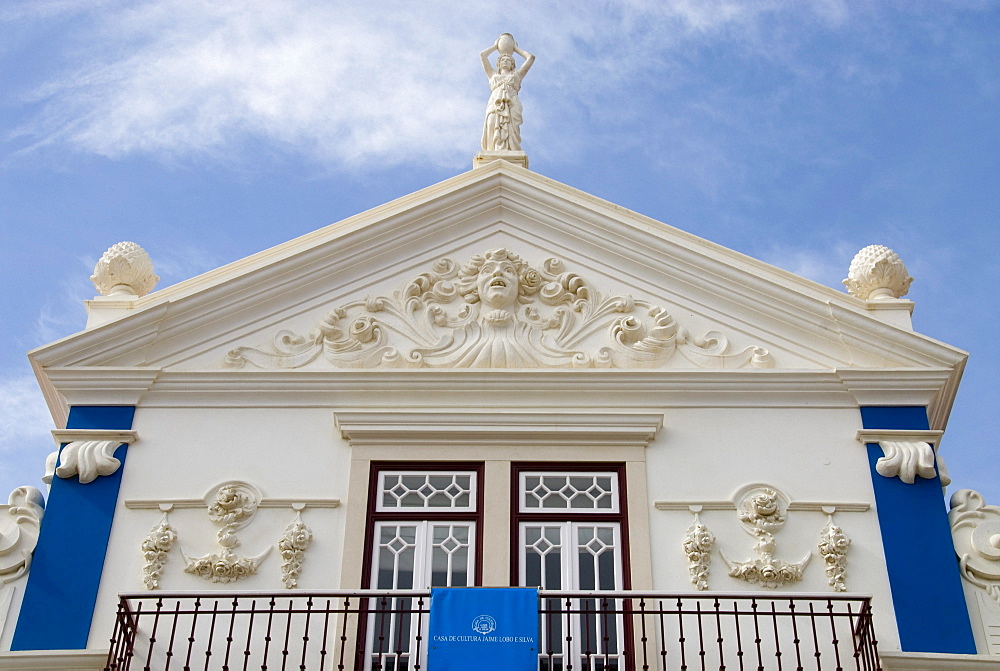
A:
[948,489,1000,604]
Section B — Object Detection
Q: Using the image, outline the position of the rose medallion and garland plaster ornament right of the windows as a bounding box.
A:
[720,486,812,588]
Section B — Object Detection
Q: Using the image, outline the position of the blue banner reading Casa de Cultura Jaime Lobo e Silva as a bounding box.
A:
[427,587,538,671]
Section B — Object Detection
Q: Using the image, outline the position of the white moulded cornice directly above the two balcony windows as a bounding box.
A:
[334,410,663,447]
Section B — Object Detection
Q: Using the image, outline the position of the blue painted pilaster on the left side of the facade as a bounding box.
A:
[11,406,135,650]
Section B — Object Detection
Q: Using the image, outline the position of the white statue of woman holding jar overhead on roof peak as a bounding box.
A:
[480,33,535,151]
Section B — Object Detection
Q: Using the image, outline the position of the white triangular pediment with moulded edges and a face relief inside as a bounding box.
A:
[32,161,964,378]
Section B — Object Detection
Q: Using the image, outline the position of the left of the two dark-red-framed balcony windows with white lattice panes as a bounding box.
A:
[365,463,482,671]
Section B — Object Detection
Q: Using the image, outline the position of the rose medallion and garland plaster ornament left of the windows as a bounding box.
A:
[182,482,271,583]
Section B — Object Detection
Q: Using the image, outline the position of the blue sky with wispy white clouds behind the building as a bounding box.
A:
[0,0,1000,504]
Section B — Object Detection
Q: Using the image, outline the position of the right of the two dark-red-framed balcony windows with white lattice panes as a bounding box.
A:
[514,464,627,671]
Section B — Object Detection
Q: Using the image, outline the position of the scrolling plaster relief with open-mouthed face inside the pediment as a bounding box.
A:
[226,249,773,368]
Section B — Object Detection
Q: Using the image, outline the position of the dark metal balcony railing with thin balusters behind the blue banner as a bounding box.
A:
[105,590,880,671]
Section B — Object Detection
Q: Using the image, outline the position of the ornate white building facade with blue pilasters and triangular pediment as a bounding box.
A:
[0,159,1000,671]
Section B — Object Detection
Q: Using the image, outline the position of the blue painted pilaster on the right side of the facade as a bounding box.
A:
[861,406,976,654]
